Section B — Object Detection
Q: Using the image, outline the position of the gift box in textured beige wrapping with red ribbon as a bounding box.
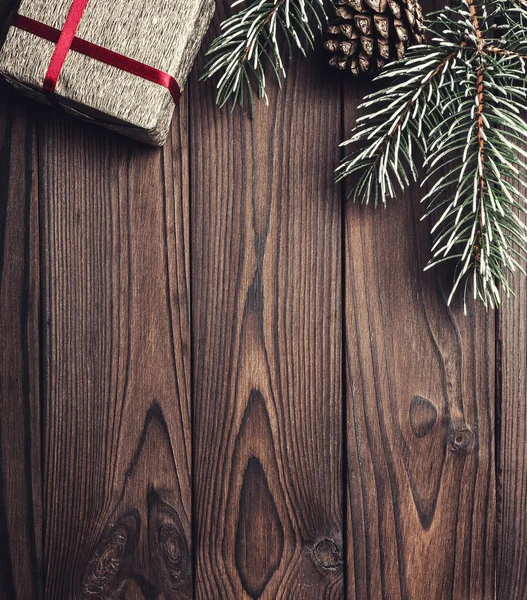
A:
[0,0,214,146]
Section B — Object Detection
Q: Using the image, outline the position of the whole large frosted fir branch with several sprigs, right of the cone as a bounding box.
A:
[336,0,527,307]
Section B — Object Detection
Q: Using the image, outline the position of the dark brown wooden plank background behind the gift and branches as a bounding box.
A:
[0,0,527,600]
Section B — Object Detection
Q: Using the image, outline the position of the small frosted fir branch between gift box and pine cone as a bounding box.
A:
[202,0,327,110]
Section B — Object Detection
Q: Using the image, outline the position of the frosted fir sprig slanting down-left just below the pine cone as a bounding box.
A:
[336,43,462,205]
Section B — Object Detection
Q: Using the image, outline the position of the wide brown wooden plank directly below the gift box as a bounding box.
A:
[40,98,192,600]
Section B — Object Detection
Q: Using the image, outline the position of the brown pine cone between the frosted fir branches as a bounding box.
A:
[324,0,425,75]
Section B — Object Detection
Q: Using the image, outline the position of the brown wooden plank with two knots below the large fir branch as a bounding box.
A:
[344,86,495,600]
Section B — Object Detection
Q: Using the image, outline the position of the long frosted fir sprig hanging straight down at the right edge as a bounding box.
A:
[423,59,527,306]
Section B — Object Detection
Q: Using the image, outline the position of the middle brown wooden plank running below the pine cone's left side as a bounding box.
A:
[191,8,344,600]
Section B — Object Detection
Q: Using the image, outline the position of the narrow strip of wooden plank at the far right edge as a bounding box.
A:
[497,218,527,600]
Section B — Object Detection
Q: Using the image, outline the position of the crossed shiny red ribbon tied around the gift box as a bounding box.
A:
[13,0,181,103]
